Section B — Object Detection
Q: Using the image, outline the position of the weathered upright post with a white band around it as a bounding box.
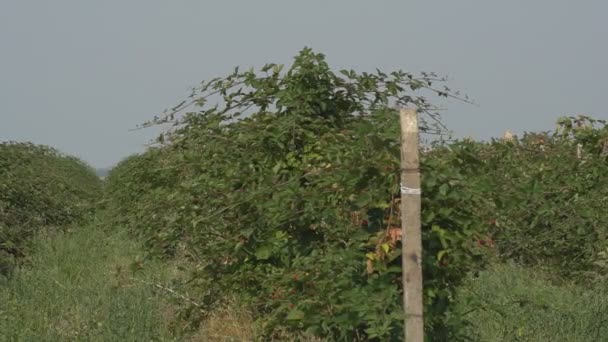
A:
[399,108,424,342]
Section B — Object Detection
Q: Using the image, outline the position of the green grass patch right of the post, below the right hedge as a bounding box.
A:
[454,265,608,342]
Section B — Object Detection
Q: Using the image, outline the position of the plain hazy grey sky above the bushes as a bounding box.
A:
[0,0,608,167]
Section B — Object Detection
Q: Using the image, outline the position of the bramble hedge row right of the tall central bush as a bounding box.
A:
[454,117,608,281]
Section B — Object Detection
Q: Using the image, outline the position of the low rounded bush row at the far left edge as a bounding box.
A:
[0,142,101,273]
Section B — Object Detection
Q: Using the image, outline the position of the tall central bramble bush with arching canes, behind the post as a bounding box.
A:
[107,50,489,341]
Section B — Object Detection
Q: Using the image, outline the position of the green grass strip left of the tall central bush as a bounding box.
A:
[0,220,178,341]
